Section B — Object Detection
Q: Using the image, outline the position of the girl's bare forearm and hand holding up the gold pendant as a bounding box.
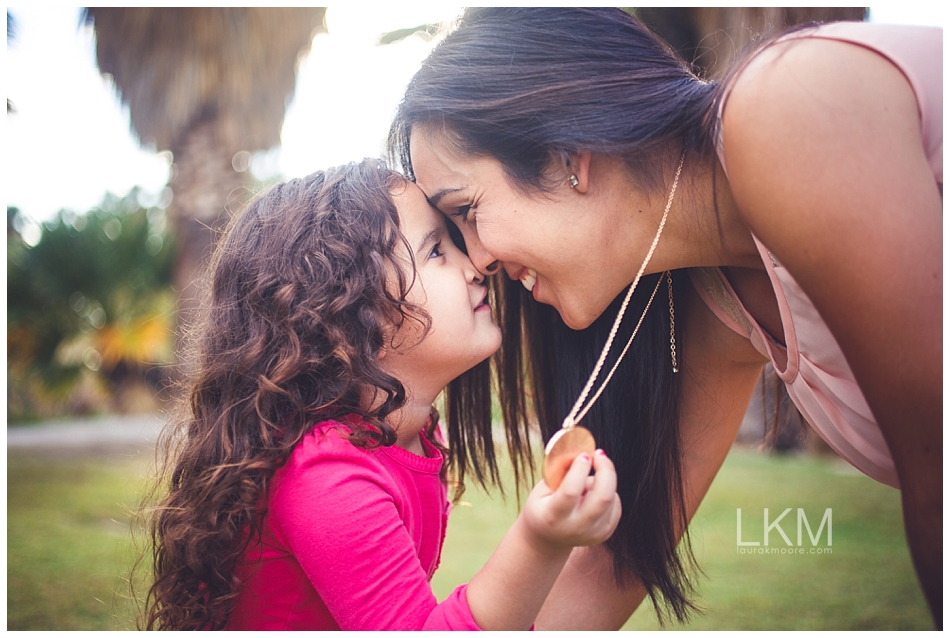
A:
[467,450,620,630]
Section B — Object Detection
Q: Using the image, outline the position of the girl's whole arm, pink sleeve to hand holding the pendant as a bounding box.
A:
[268,433,620,631]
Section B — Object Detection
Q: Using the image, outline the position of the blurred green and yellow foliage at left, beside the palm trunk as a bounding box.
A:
[7,189,175,421]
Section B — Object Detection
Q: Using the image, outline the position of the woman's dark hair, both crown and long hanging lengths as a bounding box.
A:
[389,8,717,621]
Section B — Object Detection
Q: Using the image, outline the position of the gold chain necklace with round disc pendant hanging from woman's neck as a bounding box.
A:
[542,152,686,490]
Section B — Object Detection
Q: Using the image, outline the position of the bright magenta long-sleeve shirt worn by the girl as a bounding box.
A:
[227,422,478,630]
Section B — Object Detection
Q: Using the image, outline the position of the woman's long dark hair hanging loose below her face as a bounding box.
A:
[492,271,696,621]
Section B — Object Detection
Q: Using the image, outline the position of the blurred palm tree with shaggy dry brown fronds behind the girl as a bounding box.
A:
[86,7,326,360]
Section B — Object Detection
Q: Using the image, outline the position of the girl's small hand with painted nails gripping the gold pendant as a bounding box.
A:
[520,450,621,552]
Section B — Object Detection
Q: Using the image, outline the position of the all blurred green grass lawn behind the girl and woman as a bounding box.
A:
[7,448,932,630]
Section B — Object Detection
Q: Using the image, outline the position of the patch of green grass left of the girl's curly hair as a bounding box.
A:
[7,452,148,631]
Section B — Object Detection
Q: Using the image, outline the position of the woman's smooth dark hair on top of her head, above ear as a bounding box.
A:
[389,8,716,190]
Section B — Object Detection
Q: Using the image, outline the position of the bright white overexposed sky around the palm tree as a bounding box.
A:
[0,2,944,239]
